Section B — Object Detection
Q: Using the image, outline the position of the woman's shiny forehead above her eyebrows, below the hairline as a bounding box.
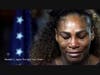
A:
[58,15,87,29]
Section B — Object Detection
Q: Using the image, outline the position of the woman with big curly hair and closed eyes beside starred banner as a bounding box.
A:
[30,9,100,65]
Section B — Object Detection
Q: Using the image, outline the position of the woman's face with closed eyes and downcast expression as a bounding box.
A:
[55,14,93,63]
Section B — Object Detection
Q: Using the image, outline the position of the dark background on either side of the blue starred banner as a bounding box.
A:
[0,9,49,64]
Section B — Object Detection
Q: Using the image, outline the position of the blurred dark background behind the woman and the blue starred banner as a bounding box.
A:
[0,9,100,64]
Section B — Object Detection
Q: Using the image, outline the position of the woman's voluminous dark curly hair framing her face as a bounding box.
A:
[30,9,100,65]
